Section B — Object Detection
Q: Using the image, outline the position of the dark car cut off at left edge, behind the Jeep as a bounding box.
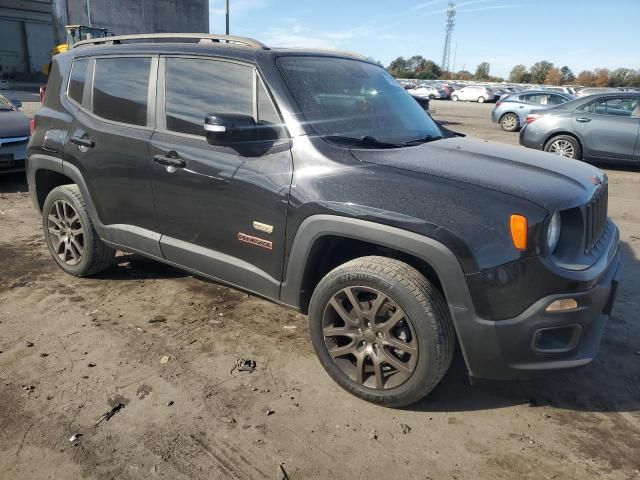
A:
[0,95,29,175]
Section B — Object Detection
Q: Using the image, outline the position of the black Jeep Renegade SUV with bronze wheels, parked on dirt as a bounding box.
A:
[27,34,621,406]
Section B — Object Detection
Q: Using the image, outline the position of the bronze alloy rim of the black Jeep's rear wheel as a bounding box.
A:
[47,200,85,266]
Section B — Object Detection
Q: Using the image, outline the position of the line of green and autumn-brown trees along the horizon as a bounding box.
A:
[387,55,640,87]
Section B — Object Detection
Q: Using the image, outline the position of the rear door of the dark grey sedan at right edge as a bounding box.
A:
[572,95,640,160]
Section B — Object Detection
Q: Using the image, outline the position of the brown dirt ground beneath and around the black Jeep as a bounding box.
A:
[0,95,640,480]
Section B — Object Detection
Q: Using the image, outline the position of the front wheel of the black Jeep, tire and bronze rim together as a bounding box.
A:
[309,256,455,407]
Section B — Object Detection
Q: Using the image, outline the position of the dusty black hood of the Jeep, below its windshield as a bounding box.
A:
[352,138,604,211]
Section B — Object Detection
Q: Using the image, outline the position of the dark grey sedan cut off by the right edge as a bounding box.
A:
[520,92,640,162]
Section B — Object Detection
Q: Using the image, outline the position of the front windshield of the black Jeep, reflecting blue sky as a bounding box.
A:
[278,56,442,148]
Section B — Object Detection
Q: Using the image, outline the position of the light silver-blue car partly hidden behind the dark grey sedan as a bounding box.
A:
[491,90,575,132]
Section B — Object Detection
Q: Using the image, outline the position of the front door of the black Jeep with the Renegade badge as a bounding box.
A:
[151,57,292,297]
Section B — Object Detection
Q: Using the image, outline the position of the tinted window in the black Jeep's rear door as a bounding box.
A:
[93,58,151,125]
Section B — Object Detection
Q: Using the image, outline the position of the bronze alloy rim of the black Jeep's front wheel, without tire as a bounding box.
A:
[322,287,418,390]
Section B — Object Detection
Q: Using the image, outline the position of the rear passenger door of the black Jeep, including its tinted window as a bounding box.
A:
[64,56,160,256]
